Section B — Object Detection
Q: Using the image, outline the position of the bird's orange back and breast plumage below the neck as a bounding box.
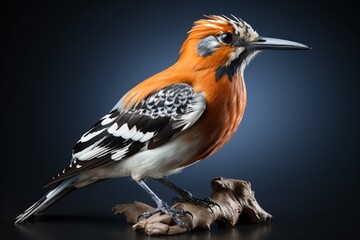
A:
[124,62,246,167]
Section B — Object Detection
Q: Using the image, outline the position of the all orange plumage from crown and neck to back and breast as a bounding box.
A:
[124,16,246,167]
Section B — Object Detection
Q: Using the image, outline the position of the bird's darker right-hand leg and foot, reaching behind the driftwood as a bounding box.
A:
[155,178,220,211]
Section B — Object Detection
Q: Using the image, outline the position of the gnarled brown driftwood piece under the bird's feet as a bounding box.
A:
[113,177,272,235]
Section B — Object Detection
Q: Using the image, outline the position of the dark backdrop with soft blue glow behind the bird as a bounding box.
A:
[0,1,360,239]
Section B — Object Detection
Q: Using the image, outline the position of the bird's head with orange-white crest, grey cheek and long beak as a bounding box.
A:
[179,15,309,79]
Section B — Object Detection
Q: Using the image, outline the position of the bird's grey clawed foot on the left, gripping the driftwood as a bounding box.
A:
[139,201,192,231]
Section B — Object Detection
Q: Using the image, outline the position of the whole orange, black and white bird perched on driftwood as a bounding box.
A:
[16,15,309,227]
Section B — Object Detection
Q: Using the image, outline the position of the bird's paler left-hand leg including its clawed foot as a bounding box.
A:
[137,180,188,229]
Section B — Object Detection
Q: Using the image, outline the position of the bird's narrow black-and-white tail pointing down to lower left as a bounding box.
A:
[15,178,74,223]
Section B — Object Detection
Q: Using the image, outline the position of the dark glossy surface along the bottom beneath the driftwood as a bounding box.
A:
[5,215,359,240]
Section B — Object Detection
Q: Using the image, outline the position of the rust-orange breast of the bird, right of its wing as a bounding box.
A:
[182,71,246,167]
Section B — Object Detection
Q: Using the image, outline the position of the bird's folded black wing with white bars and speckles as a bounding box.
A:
[47,83,206,185]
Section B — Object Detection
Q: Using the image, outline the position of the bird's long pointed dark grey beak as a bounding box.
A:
[247,37,311,50]
